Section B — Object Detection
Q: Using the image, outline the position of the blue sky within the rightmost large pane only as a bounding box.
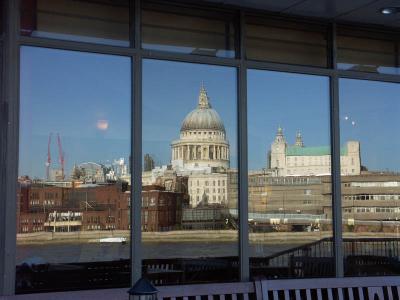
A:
[339,79,400,171]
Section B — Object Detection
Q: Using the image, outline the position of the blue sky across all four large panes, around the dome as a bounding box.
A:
[19,47,400,177]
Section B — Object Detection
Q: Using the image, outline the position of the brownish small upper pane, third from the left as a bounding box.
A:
[246,18,328,67]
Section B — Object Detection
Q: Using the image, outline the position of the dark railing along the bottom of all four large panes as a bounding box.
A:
[16,238,400,293]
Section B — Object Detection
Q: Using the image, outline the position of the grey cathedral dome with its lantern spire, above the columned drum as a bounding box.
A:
[181,87,225,132]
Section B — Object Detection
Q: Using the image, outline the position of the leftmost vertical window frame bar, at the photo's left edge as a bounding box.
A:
[0,0,19,295]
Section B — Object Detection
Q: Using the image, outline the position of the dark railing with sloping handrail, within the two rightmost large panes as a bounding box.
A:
[250,238,400,279]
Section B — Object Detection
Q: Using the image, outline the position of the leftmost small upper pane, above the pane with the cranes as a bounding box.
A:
[21,0,130,47]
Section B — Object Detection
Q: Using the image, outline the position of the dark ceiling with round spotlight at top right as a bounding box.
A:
[195,0,400,27]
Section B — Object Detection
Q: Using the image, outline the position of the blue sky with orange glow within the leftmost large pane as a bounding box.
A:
[19,47,131,177]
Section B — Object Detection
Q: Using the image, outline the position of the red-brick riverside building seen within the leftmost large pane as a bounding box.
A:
[17,181,130,233]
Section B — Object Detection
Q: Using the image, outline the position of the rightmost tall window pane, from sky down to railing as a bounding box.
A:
[339,79,400,276]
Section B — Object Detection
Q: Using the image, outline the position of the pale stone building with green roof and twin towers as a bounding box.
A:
[268,127,361,176]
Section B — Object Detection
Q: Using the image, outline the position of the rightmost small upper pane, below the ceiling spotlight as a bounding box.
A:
[337,28,400,74]
